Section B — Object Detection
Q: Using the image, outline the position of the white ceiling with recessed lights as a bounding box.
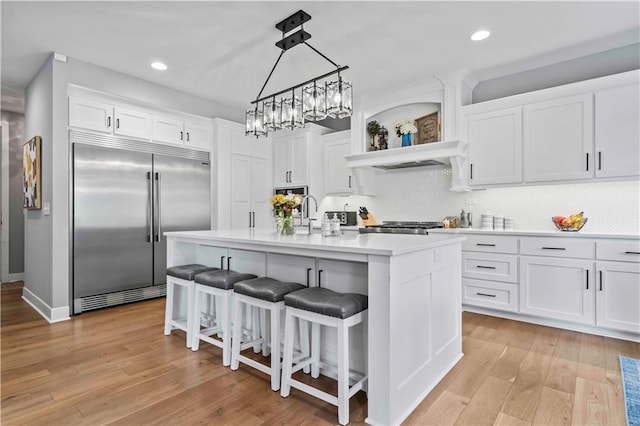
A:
[0,1,640,114]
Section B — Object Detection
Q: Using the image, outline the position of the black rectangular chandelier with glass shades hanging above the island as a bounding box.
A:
[245,10,353,137]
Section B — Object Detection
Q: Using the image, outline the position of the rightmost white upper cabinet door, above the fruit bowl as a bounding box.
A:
[595,84,640,177]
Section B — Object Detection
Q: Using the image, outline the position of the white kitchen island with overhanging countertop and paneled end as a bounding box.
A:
[165,229,464,424]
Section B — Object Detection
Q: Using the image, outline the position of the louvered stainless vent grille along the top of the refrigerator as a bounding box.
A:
[69,130,209,162]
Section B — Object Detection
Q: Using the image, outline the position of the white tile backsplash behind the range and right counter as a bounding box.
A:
[312,167,640,235]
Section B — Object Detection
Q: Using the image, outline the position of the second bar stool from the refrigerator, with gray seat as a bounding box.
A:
[191,270,257,367]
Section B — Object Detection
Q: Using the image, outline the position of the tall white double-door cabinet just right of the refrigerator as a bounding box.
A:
[231,154,273,229]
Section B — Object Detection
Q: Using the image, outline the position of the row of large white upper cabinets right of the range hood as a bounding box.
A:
[462,71,640,188]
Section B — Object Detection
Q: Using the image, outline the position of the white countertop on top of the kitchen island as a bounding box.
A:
[164,229,464,256]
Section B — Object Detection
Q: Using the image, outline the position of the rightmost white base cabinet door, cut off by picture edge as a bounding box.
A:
[596,262,640,333]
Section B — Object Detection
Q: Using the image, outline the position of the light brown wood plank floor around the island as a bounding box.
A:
[0,282,640,425]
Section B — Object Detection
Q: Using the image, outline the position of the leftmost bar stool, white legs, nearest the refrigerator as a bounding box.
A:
[164,263,219,348]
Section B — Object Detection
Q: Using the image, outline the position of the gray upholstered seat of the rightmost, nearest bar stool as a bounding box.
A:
[284,287,369,319]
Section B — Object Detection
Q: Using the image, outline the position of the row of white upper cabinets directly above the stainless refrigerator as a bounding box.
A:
[69,88,212,151]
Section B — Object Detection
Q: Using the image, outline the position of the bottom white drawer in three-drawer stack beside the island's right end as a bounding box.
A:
[462,278,518,312]
